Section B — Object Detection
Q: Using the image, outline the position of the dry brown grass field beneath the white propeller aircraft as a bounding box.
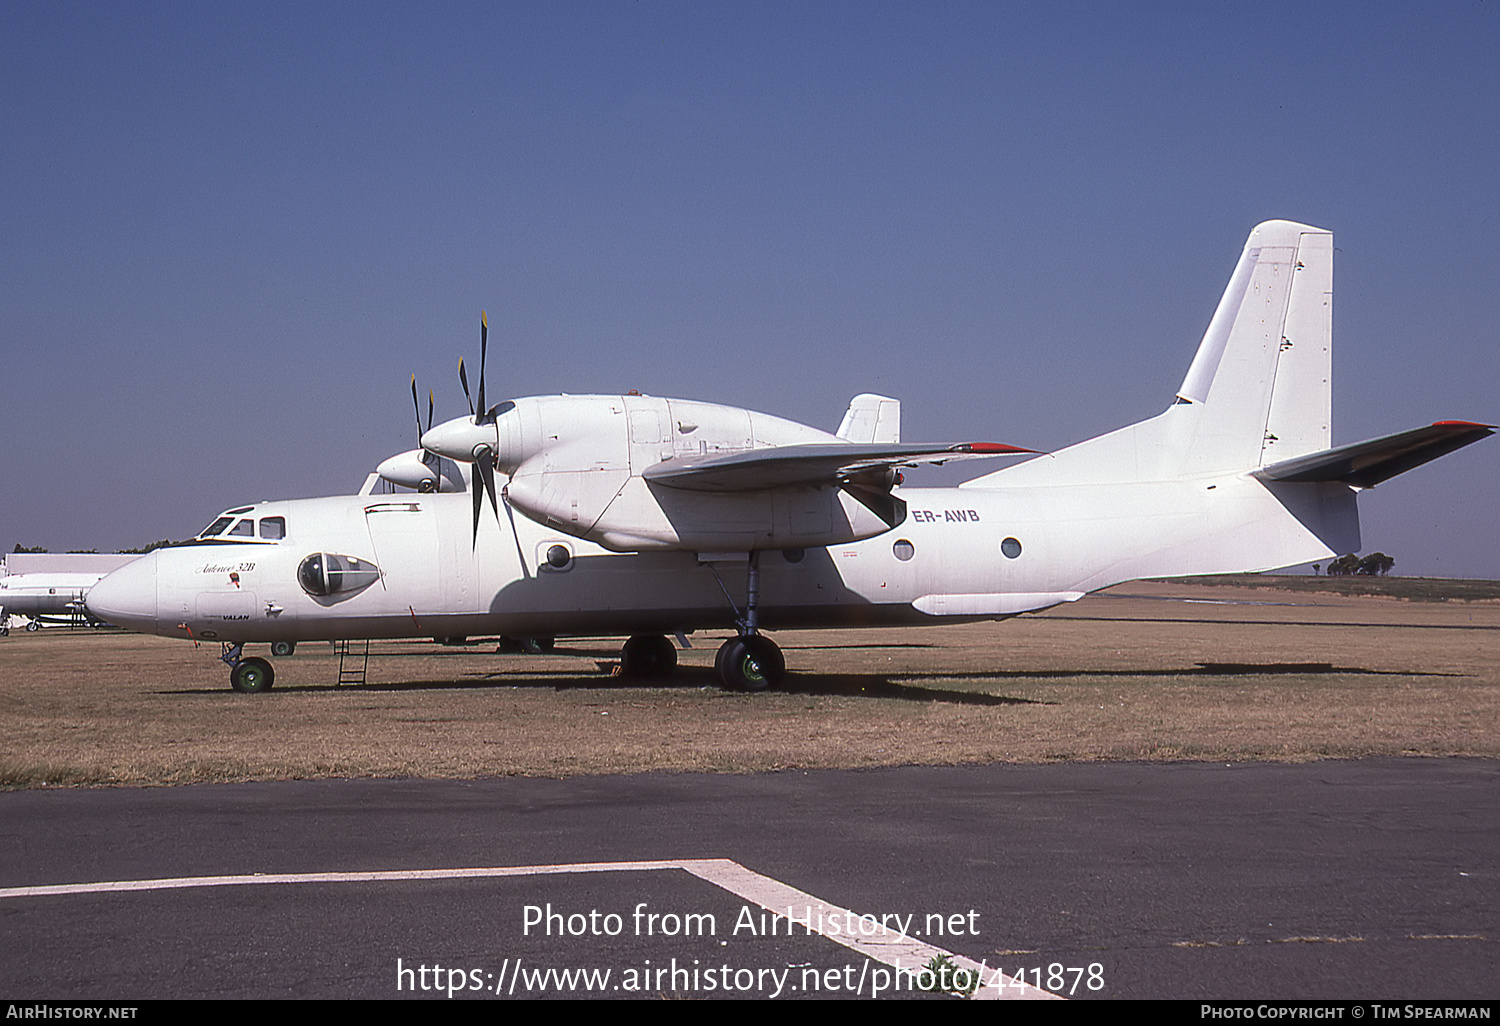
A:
[0,581,1500,788]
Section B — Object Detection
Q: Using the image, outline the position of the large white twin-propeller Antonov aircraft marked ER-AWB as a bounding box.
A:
[89,221,1493,692]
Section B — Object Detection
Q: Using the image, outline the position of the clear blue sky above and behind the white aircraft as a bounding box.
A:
[0,0,1500,578]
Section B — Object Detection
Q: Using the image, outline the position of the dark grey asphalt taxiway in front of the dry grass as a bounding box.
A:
[0,759,1500,1001]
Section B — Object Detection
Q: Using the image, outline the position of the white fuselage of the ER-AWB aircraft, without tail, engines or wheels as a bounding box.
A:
[79,474,1349,642]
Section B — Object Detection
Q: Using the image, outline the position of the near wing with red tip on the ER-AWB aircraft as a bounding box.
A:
[642,443,1037,492]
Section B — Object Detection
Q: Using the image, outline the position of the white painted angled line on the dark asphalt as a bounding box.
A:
[0,858,1059,1001]
